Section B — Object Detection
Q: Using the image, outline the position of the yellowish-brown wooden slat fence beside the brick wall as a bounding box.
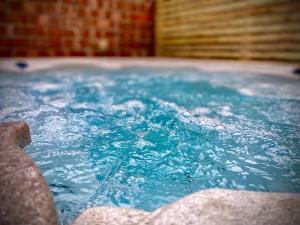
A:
[155,0,300,62]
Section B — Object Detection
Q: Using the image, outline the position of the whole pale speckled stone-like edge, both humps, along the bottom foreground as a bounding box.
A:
[72,189,300,225]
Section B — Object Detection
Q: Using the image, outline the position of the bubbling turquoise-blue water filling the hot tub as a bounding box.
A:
[0,68,300,224]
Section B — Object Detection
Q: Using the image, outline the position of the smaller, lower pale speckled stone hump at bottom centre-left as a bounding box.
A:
[72,207,149,225]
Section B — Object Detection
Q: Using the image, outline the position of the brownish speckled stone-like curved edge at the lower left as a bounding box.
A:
[0,122,58,225]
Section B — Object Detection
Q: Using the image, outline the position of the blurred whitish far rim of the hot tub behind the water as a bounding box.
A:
[0,57,299,78]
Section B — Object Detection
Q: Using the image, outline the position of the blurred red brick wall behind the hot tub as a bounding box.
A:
[0,0,153,57]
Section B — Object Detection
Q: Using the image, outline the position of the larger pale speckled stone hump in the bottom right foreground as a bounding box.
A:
[140,189,300,225]
